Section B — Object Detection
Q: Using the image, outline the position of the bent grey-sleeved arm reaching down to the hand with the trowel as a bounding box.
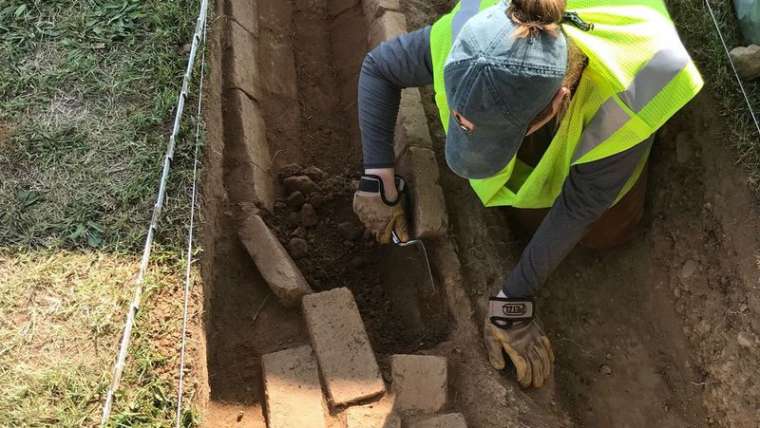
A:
[358,26,433,199]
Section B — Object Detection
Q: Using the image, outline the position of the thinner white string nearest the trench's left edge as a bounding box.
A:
[175,15,207,428]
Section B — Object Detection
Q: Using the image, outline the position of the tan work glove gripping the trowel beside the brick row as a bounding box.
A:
[354,175,409,244]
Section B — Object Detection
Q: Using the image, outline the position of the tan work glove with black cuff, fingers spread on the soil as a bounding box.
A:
[483,297,554,388]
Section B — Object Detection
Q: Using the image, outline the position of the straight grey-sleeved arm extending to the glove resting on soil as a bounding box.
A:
[500,138,652,297]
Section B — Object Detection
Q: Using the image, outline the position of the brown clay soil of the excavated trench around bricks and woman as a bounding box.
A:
[197,0,760,428]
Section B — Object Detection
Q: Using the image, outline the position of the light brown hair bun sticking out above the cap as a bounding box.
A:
[507,0,565,38]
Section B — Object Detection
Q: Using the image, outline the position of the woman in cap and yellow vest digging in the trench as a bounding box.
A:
[354,0,703,387]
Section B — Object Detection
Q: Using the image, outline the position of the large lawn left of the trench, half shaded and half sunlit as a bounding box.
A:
[0,0,205,427]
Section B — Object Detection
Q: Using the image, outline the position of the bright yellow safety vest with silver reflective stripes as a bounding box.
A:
[430,0,704,208]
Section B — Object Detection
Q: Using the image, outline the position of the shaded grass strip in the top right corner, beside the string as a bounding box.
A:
[666,0,760,187]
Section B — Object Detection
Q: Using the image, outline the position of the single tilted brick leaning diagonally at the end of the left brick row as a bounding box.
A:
[238,214,312,307]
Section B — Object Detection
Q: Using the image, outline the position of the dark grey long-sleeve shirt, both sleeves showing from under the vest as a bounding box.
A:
[359,26,651,297]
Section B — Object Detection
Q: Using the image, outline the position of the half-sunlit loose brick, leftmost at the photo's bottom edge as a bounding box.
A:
[261,345,327,428]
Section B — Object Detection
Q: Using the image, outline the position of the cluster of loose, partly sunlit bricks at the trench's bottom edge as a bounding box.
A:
[262,288,467,428]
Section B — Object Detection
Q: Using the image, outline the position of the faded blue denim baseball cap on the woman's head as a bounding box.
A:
[443,0,567,179]
